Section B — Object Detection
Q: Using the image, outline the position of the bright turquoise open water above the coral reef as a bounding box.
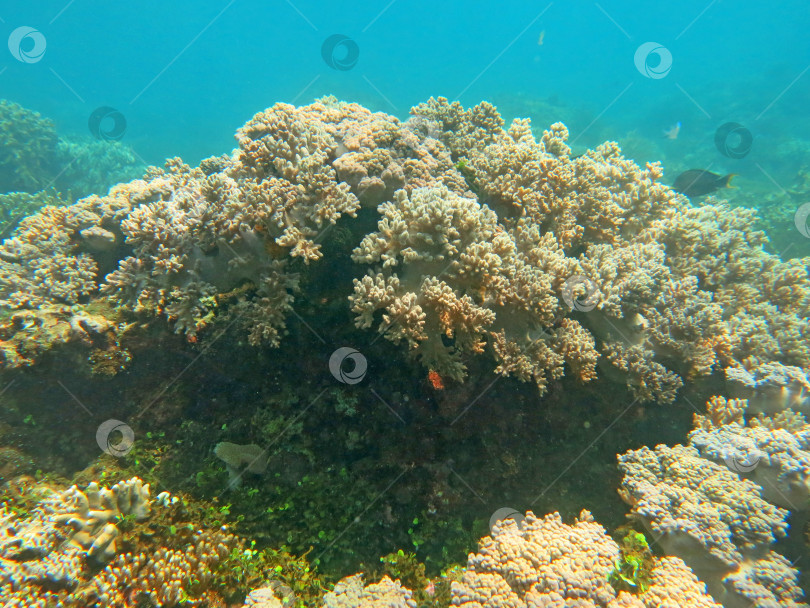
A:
[0,0,810,181]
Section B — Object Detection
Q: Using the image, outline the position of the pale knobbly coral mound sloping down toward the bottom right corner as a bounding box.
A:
[619,442,806,608]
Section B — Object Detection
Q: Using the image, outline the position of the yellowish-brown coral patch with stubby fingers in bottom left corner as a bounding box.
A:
[0,478,240,608]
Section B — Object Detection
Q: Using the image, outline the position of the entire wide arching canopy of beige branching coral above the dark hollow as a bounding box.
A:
[0,98,810,402]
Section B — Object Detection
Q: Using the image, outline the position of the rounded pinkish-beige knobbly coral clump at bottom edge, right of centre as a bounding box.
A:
[452,511,719,608]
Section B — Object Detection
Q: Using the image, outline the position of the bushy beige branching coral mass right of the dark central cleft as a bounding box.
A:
[352,100,810,402]
